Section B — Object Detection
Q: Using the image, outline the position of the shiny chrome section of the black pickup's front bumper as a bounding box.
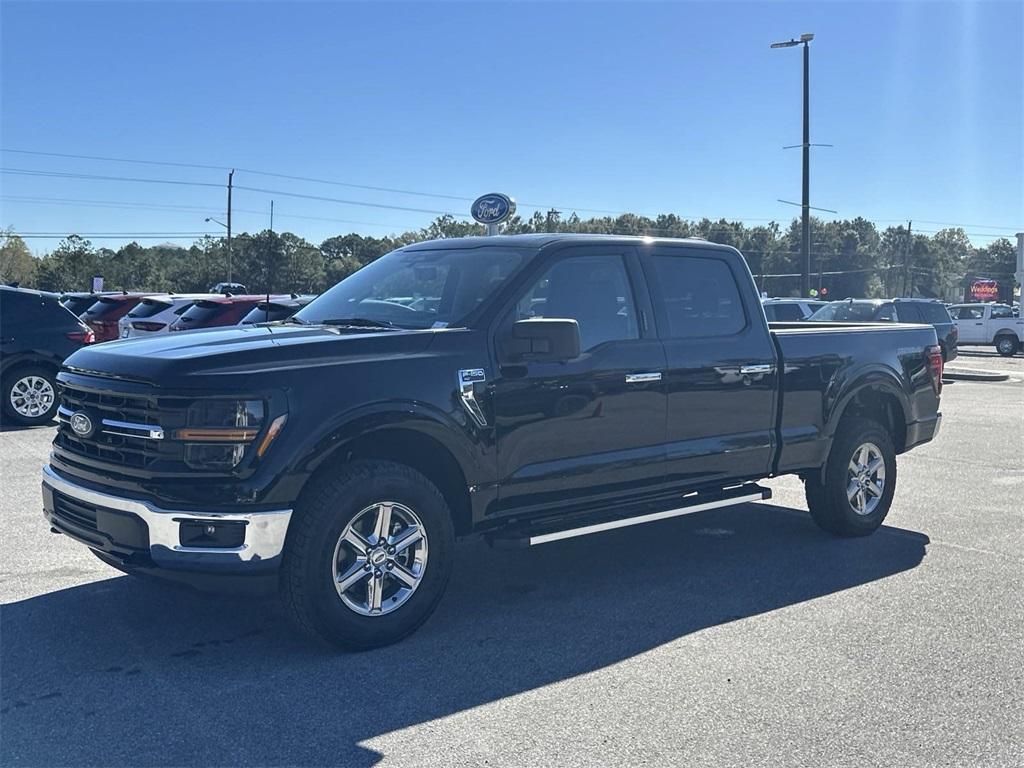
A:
[43,466,292,571]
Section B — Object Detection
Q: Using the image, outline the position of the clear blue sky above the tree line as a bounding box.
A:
[0,0,1024,253]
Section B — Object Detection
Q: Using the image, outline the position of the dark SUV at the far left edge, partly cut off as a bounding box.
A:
[0,286,93,426]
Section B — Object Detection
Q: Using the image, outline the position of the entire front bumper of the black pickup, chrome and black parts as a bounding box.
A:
[43,466,292,573]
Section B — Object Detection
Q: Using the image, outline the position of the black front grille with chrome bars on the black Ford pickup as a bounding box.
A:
[53,378,191,472]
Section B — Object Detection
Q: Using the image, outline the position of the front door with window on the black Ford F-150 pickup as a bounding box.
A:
[488,247,666,514]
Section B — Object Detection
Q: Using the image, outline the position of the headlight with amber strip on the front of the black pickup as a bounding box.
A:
[175,399,266,469]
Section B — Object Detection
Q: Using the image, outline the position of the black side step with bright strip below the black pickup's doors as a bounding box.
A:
[487,482,771,549]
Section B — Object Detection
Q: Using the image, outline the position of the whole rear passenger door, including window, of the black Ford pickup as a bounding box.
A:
[643,246,778,486]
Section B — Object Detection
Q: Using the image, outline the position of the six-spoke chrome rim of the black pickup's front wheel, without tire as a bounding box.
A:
[333,502,427,616]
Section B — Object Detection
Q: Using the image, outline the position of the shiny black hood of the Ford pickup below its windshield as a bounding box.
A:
[65,326,437,388]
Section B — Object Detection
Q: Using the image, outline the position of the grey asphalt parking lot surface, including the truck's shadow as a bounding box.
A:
[0,350,1024,768]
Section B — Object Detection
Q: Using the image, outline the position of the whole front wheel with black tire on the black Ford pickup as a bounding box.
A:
[281,461,455,650]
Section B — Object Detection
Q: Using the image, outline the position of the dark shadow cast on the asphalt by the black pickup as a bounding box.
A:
[0,504,929,766]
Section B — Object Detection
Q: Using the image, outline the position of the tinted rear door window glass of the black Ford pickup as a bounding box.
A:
[648,251,746,339]
